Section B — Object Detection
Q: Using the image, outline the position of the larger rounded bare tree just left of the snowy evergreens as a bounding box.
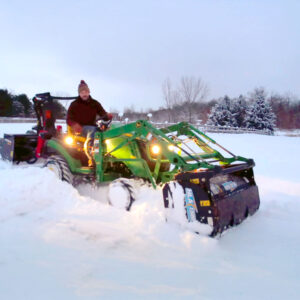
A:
[178,76,208,122]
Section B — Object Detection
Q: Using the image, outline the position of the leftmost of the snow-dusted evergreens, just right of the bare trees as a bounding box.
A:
[206,96,238,127]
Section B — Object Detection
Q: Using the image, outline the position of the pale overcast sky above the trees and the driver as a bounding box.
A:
[0,0,300,111]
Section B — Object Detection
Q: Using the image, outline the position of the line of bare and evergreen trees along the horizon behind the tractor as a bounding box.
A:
[0,81,300,131]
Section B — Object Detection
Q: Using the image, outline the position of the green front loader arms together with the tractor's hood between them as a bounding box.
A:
[90,120,254,187]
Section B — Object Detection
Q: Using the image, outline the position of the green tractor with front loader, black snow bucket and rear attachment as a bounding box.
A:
[0,93,260,236]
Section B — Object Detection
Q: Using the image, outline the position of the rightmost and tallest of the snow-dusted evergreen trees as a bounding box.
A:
[245,88,276,133]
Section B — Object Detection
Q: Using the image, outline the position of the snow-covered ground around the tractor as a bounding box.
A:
[0,123,300,300]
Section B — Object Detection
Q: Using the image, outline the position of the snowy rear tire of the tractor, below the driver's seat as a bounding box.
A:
[44,155,74,185]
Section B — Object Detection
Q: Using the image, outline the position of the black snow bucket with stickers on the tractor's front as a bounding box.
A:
[163,161,260,236]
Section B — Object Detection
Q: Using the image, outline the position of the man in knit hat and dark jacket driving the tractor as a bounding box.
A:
[67,80,113,166]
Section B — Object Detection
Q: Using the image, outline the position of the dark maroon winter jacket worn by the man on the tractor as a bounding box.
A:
[67,96,107,126]
